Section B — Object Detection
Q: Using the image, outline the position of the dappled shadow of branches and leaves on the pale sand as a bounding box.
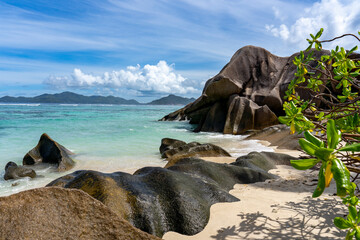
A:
[211,197,346,240]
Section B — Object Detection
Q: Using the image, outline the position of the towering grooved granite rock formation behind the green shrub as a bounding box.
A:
[162,46,329,134]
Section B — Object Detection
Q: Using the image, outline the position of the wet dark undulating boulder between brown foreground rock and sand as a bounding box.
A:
[48,153,284,237]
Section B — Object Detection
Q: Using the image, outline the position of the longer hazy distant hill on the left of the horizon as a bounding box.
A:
[0,92,140,105]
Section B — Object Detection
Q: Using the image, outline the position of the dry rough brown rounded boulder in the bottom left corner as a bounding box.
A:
[0,187,159,240]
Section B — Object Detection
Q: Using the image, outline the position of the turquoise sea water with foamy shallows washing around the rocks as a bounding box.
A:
[0,104,272,196]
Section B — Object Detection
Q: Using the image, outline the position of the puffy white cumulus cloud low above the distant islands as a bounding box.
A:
[44,61,199,94]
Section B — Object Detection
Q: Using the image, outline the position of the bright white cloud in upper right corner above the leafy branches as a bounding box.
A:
[265,0,360,48]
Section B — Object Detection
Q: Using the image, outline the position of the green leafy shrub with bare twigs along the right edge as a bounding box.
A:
[279,29,360,239]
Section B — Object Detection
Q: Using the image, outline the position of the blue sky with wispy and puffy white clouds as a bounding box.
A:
[0,0,360,102]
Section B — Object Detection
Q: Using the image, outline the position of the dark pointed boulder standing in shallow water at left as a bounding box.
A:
[23,133,75,172]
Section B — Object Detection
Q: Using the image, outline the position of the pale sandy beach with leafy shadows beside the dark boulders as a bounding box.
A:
[163,141,347,240]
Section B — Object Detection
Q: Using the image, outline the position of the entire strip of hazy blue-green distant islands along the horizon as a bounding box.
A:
[0,92,195,105]
